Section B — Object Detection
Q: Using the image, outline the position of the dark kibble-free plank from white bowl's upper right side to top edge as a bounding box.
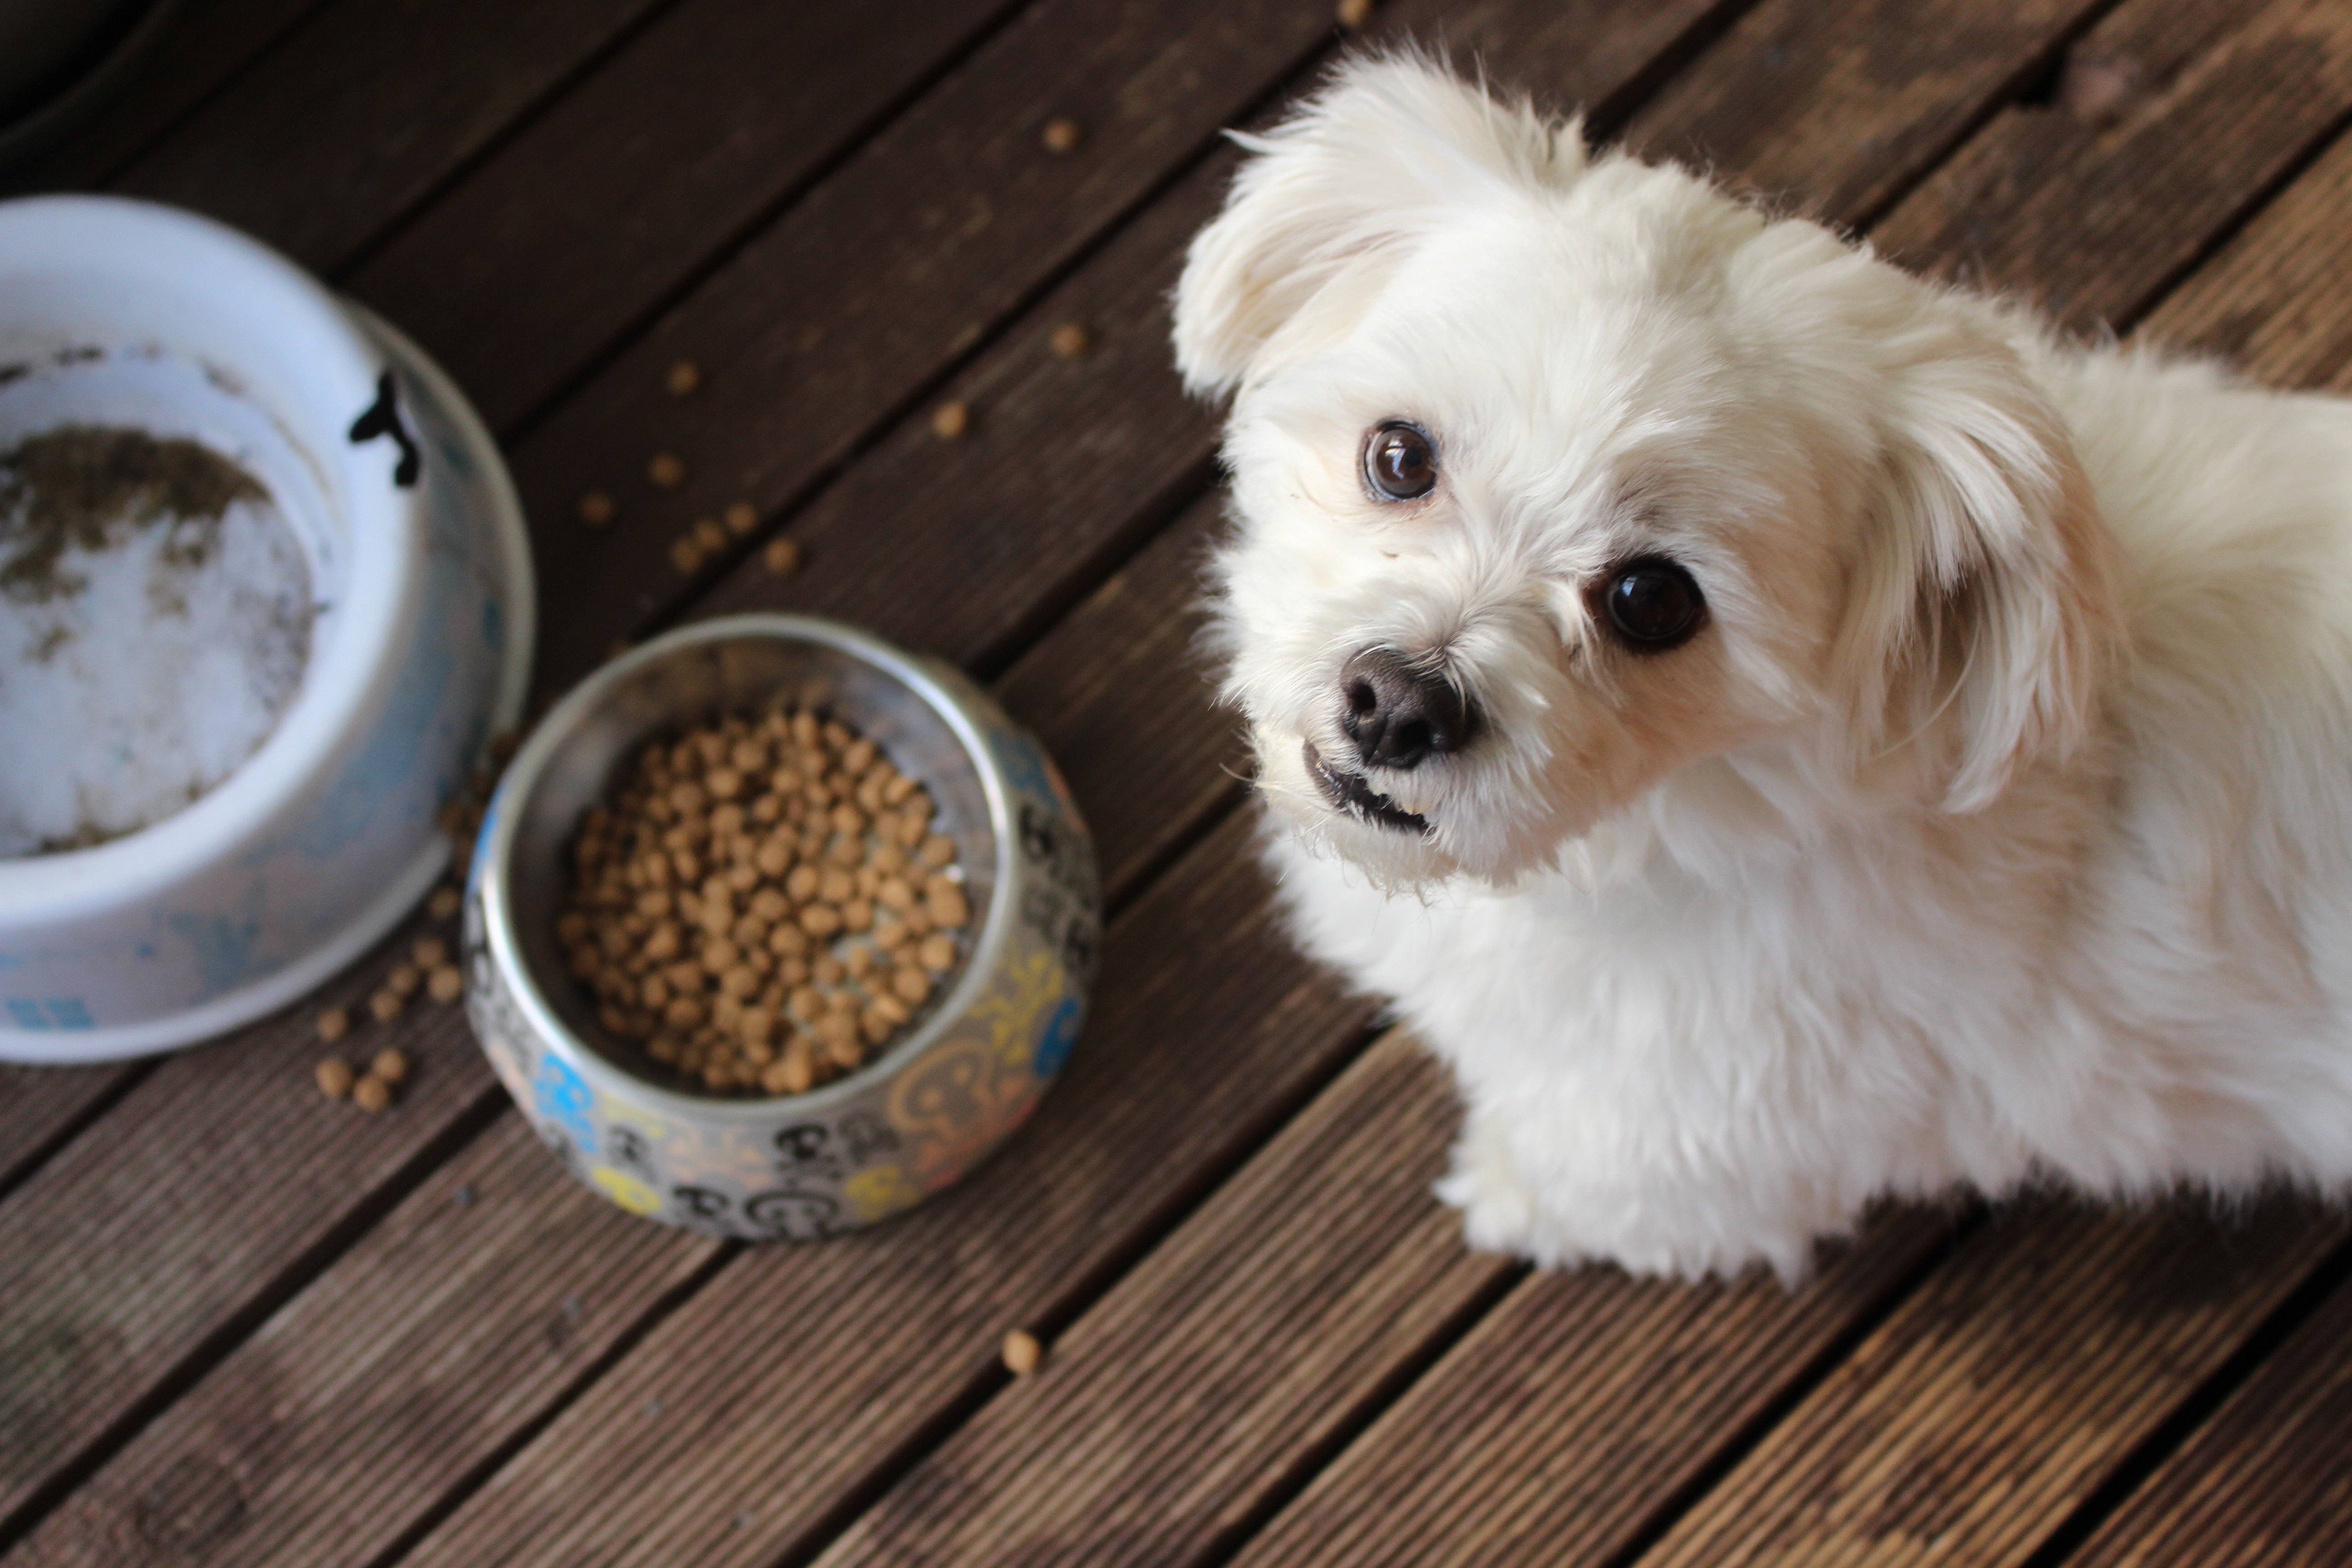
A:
[348,0,1004,428]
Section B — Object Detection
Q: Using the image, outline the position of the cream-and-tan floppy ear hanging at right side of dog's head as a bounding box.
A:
[1837,305,2122,811]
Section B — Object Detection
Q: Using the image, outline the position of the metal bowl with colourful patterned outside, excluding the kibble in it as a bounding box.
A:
[466,616,1101,1239]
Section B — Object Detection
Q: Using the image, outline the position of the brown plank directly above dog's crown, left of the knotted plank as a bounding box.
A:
[1625,0,2091,223]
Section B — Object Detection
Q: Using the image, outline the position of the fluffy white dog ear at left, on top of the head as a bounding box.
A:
[1176,52,1585,395]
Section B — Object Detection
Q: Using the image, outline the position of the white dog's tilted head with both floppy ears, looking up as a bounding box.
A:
[1176,56,2114,882]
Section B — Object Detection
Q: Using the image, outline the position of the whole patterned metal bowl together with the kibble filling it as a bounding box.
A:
[466,616,1101,1239]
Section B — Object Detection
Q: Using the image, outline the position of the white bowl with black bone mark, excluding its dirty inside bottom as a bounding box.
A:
[0,197,534,1063]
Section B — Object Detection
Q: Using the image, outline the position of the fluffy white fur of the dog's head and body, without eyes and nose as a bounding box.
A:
[1176,56,2352,1277]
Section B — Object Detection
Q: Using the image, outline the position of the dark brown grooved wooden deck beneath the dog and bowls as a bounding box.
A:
[0,0,2352,1568]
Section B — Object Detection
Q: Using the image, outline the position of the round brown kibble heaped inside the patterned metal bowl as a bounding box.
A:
[555,712,971,1096]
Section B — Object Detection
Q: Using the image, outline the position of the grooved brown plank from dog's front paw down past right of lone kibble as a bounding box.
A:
[818,1029,1514,1568]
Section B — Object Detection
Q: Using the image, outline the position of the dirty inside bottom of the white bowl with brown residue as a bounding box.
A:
[0,423,313,860]
